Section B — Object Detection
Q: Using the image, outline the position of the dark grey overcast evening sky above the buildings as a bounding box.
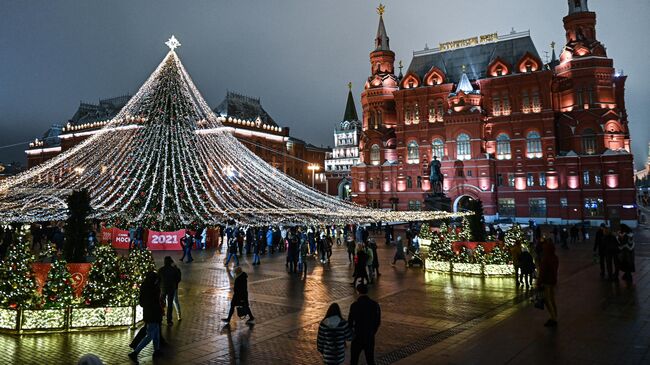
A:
[0,0,650,166]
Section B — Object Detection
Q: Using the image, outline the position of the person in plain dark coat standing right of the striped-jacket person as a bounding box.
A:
[348,284,381,365]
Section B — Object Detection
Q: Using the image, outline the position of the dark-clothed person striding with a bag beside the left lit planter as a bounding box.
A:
[129,271,163,363]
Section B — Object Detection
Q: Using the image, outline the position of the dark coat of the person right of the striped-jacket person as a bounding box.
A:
[348,295,381,345]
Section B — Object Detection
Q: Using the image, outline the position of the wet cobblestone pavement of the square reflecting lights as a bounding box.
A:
[0,225,650,364]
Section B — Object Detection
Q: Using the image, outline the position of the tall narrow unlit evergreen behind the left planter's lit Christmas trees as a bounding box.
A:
[63,189,91,262]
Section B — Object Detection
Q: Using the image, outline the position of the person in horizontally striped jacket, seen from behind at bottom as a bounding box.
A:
[316,303,352,365]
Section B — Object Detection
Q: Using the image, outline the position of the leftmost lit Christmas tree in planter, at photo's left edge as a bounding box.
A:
[0,225,38,309]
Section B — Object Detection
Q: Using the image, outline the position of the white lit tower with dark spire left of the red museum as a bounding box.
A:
[325,83,361,200]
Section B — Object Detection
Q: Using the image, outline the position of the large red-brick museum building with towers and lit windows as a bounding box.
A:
[352,0,636,225]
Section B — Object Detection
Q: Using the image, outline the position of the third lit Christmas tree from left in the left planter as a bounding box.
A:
[82,245,120,307]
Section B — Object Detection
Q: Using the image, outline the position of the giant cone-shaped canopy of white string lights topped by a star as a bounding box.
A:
[0,36,462,230]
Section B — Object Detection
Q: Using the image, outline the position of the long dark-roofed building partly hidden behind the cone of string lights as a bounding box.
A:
[25,91,329,191]
